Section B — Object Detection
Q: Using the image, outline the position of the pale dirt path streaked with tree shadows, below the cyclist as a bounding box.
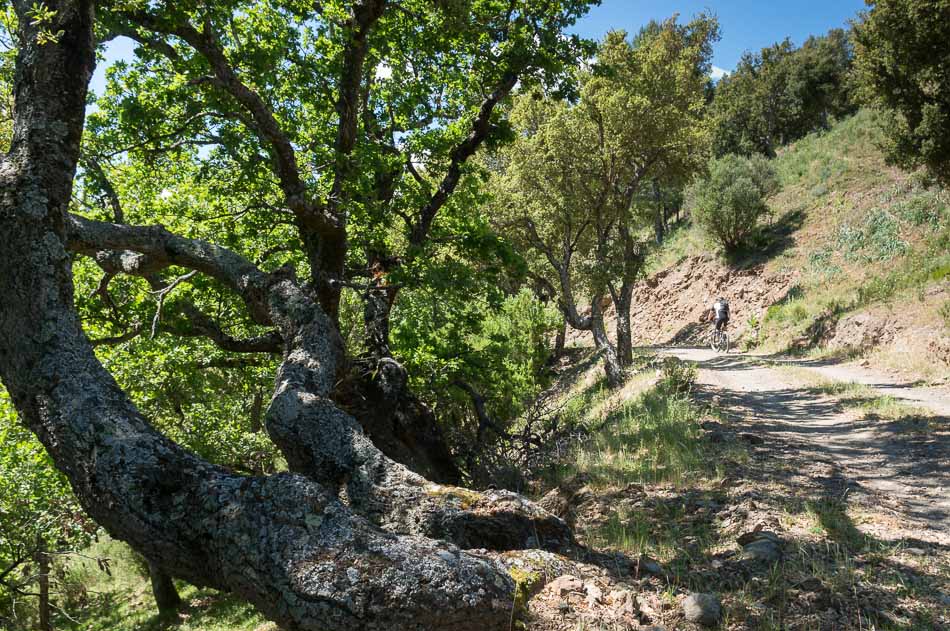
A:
[663,348,950,543]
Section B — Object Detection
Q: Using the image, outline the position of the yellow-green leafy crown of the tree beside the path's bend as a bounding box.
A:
[487,16,718,293]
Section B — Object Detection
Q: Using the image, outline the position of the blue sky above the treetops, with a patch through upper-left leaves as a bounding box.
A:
[90,0,864,94]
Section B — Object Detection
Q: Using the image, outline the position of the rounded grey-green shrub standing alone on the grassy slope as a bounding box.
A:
[686,155,778,252]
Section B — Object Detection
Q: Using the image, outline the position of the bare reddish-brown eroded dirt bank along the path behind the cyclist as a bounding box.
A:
[588,255,950,383]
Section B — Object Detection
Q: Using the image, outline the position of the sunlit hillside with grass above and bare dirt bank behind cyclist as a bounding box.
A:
[633,111,950,381]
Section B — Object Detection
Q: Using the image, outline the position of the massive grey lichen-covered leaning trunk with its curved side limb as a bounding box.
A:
[0,0,571,631]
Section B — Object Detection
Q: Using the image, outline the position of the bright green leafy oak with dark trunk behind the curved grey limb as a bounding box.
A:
[74,0,591,483]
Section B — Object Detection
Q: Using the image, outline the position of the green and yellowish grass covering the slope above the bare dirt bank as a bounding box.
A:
[759,112,950,376]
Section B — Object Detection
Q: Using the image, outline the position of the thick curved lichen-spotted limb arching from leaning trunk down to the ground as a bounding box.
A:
[68,215,573,549]
